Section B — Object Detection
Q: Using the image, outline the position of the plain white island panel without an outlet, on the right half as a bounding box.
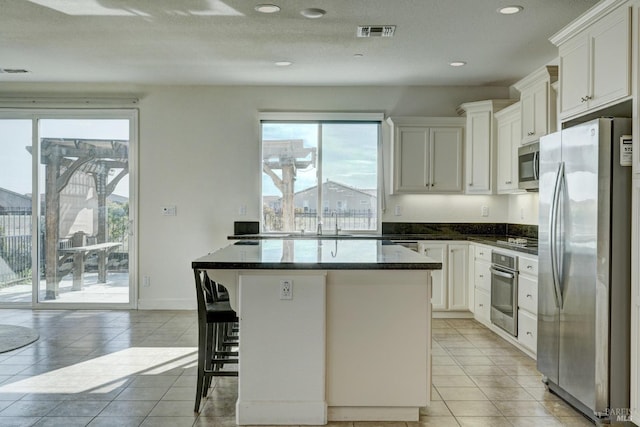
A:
[327,270,431,421]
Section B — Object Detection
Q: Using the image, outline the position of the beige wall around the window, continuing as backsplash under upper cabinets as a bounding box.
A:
[0,83,516,309]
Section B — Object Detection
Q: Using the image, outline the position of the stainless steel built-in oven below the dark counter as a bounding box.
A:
[490,251,518,337]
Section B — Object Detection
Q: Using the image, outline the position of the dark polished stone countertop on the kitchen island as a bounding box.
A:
[192,239,442,270]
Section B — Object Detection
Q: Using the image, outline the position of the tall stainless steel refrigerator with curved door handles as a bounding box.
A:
[537,118,631,420]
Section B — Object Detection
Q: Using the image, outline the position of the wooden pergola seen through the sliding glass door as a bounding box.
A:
[40,138,129,300]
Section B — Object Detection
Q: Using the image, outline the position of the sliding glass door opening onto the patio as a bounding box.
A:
[0,110,137,308]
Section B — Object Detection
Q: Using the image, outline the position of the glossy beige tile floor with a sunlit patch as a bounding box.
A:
[0,309,591,427]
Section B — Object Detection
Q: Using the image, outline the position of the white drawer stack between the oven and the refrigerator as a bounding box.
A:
[518,255,538,354]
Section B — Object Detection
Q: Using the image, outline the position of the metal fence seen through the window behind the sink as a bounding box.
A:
[263,209,377,233]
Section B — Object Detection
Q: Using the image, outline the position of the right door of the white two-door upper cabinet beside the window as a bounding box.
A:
[428,128,462,193]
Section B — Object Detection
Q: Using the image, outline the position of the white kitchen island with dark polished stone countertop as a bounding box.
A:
[192,239,442,425]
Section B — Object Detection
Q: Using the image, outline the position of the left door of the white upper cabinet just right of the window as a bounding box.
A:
[393,127,429,193]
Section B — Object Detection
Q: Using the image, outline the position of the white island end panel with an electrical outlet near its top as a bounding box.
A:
[236,271,327,425]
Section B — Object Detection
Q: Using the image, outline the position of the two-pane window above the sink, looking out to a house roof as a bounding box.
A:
[261,113,382,232]
